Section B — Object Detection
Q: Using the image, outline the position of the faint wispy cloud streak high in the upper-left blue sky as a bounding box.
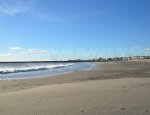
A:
[0,0,84,23]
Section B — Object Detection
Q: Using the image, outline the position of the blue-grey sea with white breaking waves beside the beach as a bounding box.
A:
[0,62,95,80]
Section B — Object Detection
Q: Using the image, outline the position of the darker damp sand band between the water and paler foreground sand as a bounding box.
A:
[0,61,150,93]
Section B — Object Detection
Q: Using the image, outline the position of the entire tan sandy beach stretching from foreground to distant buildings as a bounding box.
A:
[0,61,150,115]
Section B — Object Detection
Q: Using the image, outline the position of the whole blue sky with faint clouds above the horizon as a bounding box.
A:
[0,0,150,61]
